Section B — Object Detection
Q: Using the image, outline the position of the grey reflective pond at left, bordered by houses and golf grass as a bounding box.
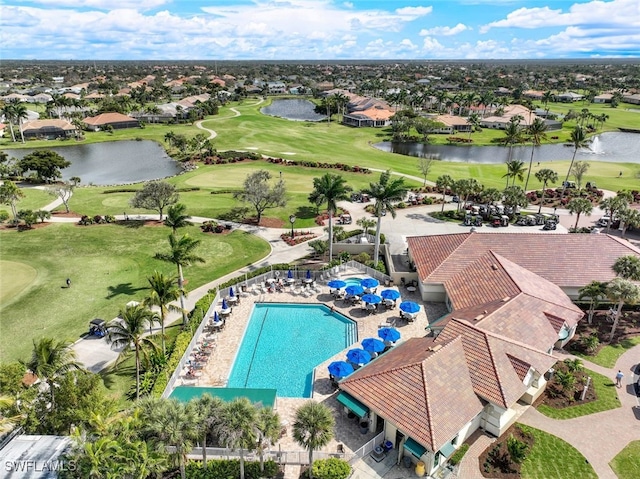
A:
[4,140,182,186]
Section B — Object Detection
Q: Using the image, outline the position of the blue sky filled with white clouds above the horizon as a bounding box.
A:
[0,0,640,60]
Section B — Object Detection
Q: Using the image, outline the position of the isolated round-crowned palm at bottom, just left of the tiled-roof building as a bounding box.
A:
[293,401,335,479]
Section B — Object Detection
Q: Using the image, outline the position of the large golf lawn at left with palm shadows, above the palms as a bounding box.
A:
[0,222,269,361]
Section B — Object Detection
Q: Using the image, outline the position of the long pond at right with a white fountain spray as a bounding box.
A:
[373,132,640,163]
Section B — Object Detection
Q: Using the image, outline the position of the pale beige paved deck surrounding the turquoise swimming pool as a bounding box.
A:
[178,271,446,464]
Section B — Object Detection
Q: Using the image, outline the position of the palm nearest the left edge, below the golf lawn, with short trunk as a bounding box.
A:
[25,338,82,410]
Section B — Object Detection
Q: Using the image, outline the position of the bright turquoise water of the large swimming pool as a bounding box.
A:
[227,303,357,397]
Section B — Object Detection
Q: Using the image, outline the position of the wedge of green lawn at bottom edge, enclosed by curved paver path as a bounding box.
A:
[518,424,598,479]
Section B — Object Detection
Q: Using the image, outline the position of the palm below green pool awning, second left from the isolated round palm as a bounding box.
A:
[216,397,258,479]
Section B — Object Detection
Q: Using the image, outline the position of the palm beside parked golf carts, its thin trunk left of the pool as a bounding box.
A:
[107,304,158,400]
